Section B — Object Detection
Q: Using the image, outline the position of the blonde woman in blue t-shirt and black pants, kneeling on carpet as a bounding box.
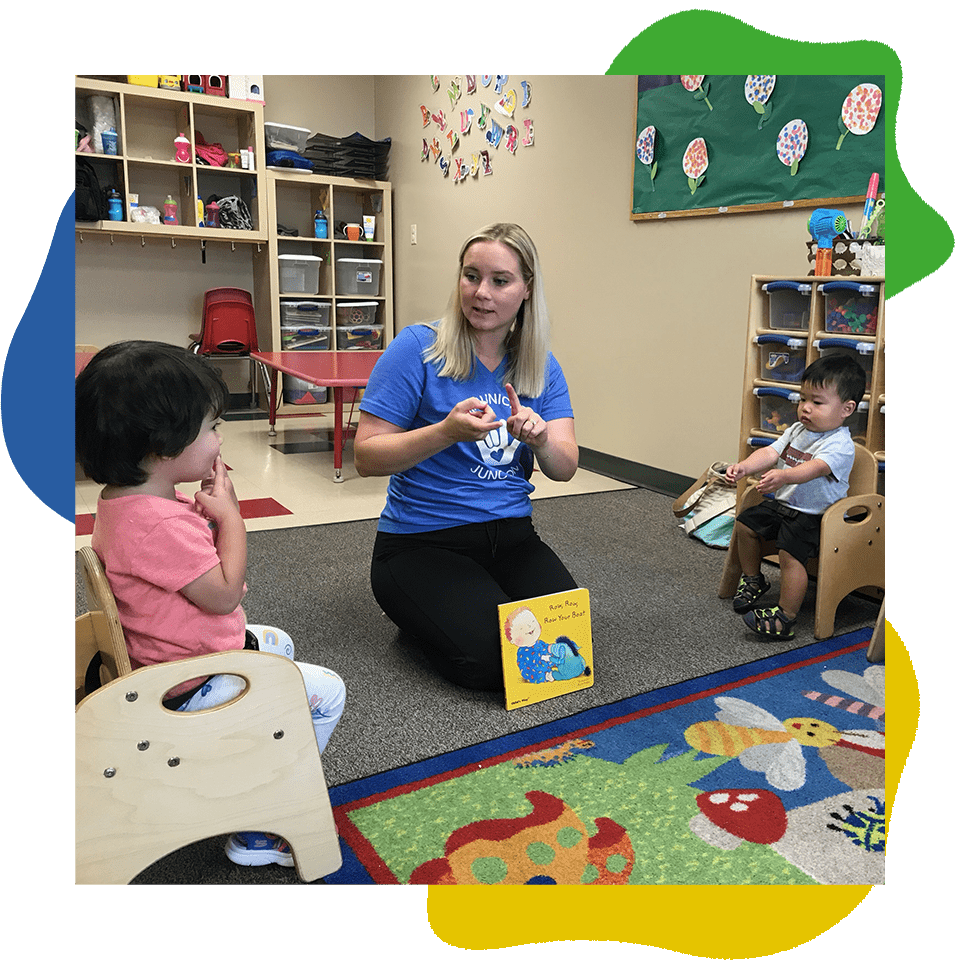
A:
[354,223,579,690]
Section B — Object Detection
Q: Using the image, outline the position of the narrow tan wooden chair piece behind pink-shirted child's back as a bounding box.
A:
[74,547,131,703]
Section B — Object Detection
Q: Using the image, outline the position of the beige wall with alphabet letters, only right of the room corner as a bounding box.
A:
[374,75,856,477]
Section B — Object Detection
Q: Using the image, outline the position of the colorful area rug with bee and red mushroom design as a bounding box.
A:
[326,630,886,884]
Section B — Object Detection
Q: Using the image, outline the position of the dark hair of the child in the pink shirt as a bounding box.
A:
[76,340,230,487]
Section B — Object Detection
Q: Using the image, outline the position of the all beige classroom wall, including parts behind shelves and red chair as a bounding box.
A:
[76,75,859,477]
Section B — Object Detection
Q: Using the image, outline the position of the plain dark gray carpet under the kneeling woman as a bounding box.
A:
[77,489,879,884]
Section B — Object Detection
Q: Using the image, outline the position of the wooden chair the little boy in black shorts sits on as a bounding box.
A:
[717,444,886,640]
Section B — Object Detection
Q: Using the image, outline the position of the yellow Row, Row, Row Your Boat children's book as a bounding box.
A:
[497,588,593,710]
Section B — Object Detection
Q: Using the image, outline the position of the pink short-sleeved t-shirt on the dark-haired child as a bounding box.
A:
[91,493,246,695]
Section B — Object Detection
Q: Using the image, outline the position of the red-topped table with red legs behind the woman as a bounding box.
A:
[251,350,383,483]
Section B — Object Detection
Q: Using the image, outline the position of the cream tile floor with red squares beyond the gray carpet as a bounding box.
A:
[76,413,629,550]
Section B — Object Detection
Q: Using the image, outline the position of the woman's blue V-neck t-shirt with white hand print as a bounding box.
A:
[360,324,573,533]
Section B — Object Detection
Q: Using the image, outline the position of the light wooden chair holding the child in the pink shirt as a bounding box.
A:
[75,547,341,884]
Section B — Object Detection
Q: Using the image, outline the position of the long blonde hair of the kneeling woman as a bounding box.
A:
[424,223,550,397]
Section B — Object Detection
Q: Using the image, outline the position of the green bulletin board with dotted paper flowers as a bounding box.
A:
[630,75,885,220]
